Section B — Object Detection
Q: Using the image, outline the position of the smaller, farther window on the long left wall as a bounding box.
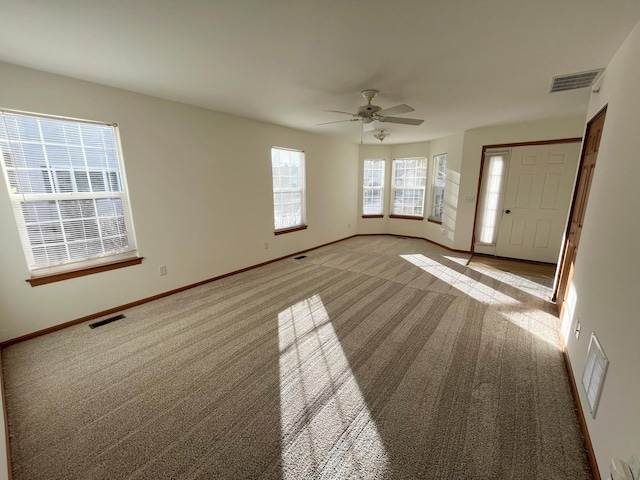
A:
[271,147,305,231]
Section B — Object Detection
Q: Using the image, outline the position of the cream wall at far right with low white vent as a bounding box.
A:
[563,19,640,478]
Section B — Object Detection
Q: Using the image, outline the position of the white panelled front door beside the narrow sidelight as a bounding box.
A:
[496,142,580,263]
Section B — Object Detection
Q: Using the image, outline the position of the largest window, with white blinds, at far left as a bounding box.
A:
[0,110,137,277]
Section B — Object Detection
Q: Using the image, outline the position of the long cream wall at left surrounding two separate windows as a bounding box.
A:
[0,64,358,341]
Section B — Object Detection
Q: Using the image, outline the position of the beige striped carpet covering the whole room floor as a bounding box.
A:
[2,236,591,480]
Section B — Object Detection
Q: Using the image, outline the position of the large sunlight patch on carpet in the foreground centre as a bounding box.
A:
[278,295,388,480]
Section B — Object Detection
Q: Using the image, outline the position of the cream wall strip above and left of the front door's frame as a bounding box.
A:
[454,115,585,250]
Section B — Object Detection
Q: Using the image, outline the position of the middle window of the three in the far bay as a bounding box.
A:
[391,157,427,219]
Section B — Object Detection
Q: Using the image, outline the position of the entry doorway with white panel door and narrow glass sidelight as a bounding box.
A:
[473,138,582,264]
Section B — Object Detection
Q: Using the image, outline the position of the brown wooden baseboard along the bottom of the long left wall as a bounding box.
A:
[0,235,357,349]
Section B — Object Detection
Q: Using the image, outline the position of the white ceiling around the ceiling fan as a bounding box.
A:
[0,0,640,143]
